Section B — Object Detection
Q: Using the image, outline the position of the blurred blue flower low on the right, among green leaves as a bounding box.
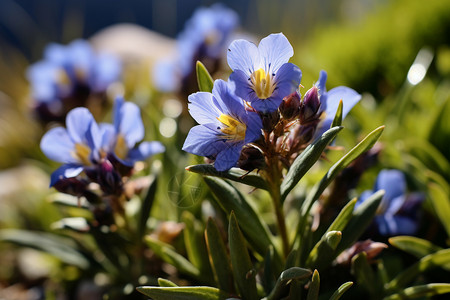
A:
[356,170,424,236]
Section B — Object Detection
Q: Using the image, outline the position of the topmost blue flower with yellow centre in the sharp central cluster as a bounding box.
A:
[227,33,302,113]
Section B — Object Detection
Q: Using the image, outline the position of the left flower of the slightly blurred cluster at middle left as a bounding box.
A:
[40,107,101,186]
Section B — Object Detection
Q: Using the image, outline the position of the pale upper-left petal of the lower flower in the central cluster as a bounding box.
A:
[188,92,222,124]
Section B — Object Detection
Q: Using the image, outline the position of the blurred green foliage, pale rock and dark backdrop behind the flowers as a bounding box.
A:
[0,0,450,298]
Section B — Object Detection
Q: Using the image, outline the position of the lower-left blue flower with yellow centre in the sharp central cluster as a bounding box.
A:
[183,80,262,171]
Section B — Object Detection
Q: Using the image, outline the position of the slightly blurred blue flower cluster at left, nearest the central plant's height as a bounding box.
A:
[41,97,164,220]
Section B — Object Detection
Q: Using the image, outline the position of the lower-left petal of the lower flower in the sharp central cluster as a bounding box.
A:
[183,125,226,156]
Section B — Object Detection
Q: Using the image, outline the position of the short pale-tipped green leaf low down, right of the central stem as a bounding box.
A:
[305,231,342,269]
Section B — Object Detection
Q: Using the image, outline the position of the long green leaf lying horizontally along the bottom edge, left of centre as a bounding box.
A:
[136,286,229,300]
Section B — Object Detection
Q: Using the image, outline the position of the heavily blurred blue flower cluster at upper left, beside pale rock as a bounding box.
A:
[27,40,122,123]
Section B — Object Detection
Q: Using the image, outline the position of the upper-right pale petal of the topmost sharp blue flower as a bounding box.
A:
[258,33,294,73]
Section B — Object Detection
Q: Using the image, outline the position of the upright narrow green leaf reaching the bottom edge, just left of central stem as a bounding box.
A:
[228,212,258,300]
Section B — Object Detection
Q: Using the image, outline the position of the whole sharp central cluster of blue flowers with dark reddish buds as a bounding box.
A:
[183,33,361,172]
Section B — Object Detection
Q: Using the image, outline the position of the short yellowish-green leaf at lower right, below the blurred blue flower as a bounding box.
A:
[389,236,442,258]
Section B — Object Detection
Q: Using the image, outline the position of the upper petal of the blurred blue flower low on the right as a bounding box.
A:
[374,170,406,202]
